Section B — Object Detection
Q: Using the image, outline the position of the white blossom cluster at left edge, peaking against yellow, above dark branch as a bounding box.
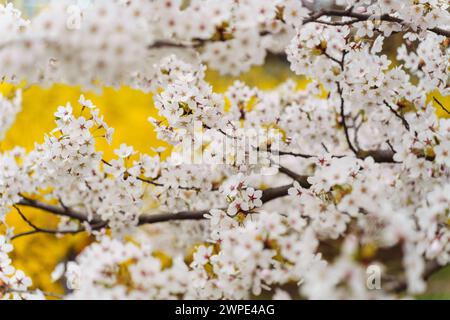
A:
[0,96,142,234]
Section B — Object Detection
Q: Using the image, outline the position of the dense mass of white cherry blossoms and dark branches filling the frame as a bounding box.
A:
[0,0,450,299]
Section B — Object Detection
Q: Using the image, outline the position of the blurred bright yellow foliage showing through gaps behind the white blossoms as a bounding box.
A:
[0,0,450,299]
